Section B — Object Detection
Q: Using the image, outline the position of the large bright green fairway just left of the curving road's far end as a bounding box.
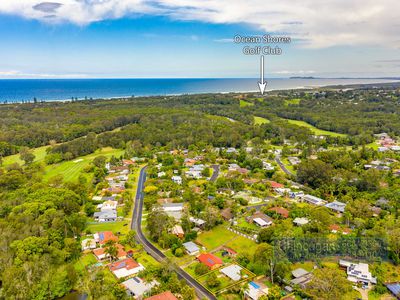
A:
[44,147,124,181]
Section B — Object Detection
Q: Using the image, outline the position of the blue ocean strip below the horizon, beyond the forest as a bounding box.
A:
[0,78,393,103]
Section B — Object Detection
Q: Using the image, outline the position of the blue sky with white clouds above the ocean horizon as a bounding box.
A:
[0,0,400,78]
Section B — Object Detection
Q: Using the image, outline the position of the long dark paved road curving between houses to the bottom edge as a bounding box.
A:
[131,167,216,300]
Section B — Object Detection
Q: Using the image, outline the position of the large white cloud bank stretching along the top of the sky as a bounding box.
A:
[0,0,400,48]
